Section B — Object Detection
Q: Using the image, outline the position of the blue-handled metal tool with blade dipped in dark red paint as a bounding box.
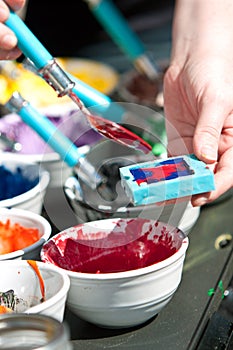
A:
[5,6,151,153]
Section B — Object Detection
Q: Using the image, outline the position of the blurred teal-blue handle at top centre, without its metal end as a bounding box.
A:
[87,0,145,61]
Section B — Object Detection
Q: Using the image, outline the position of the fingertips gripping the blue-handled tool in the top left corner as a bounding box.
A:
[0,0,25,60]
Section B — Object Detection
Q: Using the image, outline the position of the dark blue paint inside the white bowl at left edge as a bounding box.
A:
[0,165,39,200]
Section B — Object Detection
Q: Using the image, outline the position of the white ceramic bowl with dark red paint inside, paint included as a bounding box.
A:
[41,218,189,328]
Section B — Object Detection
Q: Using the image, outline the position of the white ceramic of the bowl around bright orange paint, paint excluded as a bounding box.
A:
[0,208,52,261]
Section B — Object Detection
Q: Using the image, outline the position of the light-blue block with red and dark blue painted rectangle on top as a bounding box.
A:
[119,154,215,206]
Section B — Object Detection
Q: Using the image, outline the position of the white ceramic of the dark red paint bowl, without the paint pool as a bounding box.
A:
[41,219,189,328]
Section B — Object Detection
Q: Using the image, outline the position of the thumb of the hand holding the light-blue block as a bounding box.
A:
[193,103,226,163]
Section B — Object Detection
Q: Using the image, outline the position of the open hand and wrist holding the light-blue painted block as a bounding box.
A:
[164,0,233,206]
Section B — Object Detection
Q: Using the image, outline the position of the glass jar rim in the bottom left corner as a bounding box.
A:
[0,313,72,350]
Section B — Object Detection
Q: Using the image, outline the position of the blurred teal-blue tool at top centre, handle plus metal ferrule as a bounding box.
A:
[84,0,159,80]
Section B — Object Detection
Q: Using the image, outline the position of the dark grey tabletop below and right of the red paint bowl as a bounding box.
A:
[61,193,233,350]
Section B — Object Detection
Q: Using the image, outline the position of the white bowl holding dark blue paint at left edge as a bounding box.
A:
[0,153,50,214]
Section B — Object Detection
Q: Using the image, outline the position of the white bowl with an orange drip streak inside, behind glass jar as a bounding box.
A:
[0,260,70,322]
